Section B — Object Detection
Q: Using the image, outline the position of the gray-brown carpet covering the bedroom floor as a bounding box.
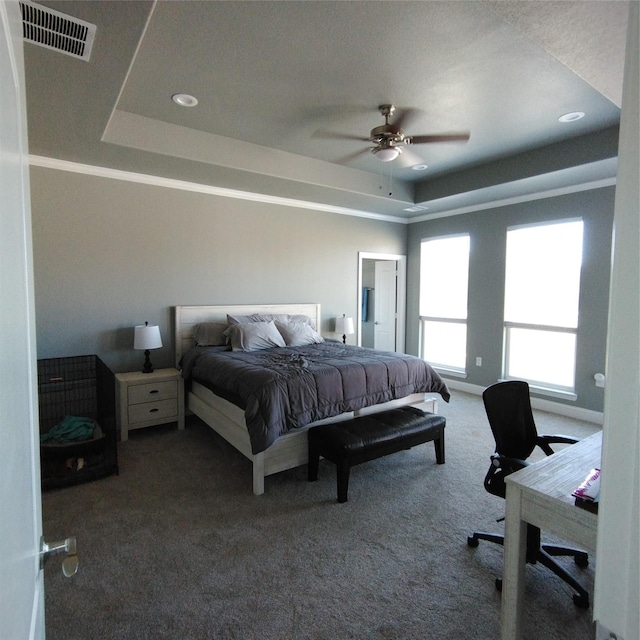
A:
[43,391,598,640]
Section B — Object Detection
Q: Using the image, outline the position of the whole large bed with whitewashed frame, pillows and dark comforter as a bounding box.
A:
[174,303,449,495]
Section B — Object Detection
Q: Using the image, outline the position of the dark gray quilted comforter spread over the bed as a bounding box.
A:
[182,342,449,453]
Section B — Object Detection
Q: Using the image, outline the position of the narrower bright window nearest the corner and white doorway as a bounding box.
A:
[420,234,469,373]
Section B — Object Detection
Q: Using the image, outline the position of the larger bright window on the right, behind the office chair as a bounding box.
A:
[504,220,583,392]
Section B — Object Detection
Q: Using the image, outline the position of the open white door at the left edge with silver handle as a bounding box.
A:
[0,0,44,639]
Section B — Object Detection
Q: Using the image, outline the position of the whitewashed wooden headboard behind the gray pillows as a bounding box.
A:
[174,303,321,368]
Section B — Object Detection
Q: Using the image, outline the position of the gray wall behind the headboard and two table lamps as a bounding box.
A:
[31,167,407,371]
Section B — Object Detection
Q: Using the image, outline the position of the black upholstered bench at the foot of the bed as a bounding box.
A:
[309,406,446,502]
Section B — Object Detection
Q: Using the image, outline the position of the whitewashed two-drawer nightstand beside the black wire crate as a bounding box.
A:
[116,369,184,442]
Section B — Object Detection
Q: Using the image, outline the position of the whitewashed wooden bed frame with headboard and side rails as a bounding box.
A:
[174,303,437,495]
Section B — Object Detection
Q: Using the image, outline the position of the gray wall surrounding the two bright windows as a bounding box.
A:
[407,187,615,411]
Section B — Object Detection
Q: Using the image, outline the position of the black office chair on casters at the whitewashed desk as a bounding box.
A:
[467,381,589,609]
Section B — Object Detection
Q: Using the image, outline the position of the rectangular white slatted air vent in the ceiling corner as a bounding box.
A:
[20,0,96,60]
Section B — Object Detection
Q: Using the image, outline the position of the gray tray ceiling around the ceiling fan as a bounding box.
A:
[25,0,628,218]
